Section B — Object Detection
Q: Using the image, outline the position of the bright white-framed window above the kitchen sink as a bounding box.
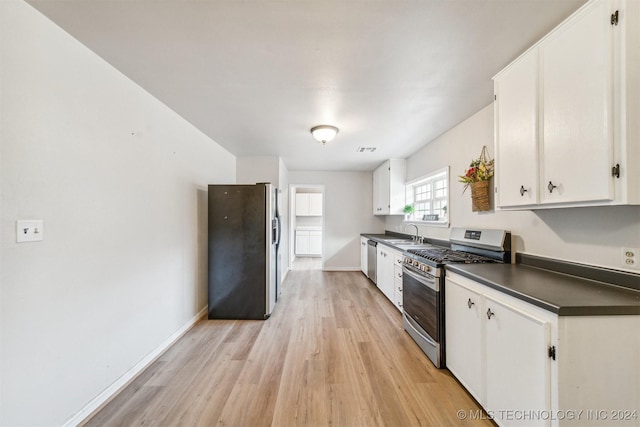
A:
[406,167,449,225]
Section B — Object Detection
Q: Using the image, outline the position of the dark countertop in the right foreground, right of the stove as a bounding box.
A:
[446,264,640,316]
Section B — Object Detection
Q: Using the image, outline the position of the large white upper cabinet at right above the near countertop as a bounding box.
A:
[494,0,640,208]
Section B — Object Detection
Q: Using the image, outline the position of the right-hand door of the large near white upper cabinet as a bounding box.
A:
[540,0,616,203]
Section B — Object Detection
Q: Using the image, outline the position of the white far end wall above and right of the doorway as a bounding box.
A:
[289,171,384,270]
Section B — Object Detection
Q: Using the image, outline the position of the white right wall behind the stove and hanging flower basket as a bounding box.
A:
[386,105,640,272]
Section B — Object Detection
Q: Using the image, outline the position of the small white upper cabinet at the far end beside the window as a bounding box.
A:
[373,159,406,215]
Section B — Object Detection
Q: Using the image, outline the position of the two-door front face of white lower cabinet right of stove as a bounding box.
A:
[445,272,555,426]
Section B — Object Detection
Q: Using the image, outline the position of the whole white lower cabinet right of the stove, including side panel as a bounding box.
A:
[445,271,640,427]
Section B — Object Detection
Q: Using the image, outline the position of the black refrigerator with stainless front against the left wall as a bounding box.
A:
[208,183,281,320]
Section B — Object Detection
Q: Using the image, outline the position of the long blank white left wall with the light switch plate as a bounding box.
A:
[0,0,235,426]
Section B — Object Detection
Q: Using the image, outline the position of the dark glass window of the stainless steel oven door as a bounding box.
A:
[402,274,440,342]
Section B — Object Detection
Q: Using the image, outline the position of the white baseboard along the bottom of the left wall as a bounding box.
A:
[63,306,207,427]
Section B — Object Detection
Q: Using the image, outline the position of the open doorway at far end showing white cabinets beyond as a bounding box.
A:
[289,184,325,270]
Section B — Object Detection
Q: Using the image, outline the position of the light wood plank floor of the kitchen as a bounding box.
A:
[85,269,492,427]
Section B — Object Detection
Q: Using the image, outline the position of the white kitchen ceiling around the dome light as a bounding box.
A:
[28,0,585,170]
